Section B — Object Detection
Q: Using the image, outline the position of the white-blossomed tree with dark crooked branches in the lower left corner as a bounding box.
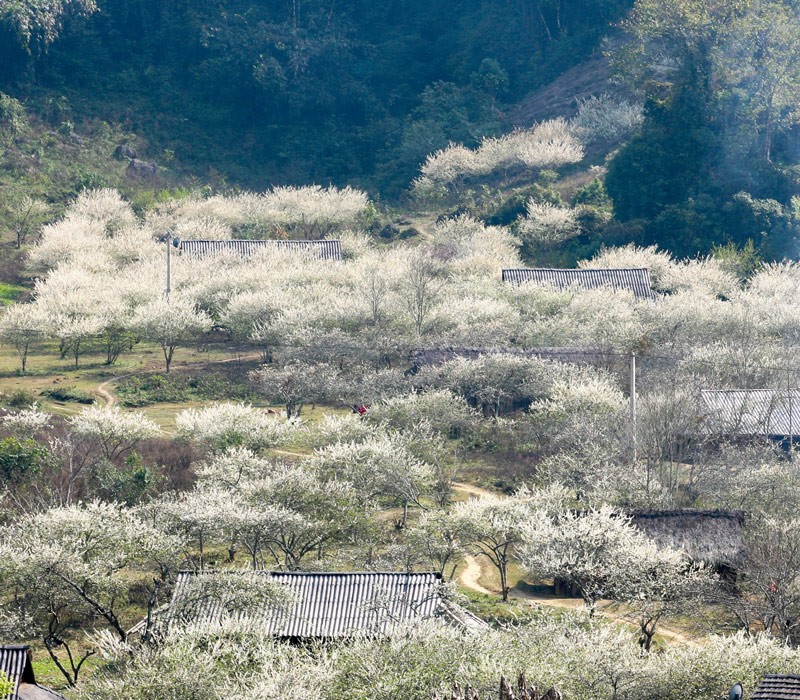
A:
[0,502,175,686]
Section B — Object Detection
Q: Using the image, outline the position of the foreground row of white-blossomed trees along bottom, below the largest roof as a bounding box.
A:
[76,615,800,700]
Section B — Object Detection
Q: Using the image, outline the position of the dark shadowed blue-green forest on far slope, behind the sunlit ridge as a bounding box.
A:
[0,0,630,193]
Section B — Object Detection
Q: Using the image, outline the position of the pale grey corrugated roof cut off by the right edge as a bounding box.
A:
[700,389,800,437]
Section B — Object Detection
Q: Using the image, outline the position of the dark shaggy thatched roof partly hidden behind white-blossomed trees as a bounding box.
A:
[630,508,744,569]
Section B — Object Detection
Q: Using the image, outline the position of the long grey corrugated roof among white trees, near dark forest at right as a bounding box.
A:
[503,267,656,299]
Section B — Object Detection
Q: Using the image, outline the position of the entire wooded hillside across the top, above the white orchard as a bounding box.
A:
[0,0,800,258]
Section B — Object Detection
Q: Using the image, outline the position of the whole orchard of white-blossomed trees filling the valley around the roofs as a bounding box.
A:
[0,112,800,700]
